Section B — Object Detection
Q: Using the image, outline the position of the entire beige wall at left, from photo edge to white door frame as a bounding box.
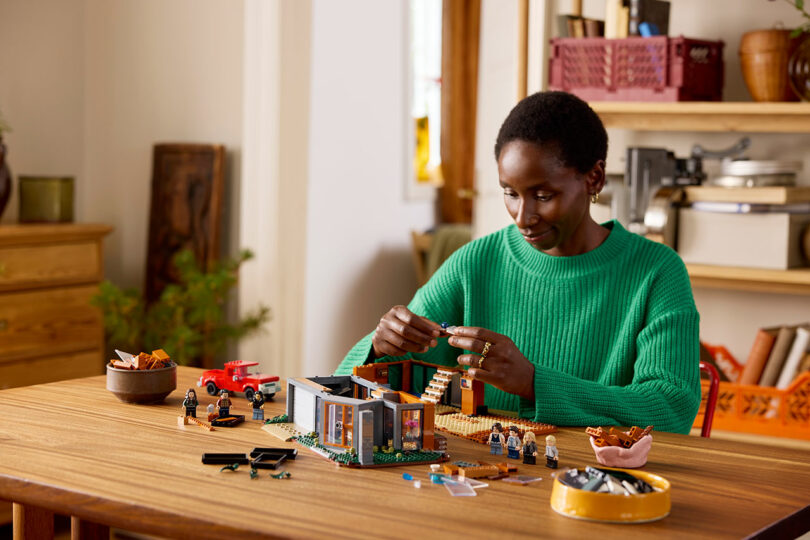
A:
[0,0,242,292]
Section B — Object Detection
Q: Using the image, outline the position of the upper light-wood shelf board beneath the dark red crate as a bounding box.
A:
[590,101,810,133]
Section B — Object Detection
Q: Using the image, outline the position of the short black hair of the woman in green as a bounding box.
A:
[495,91,607,174]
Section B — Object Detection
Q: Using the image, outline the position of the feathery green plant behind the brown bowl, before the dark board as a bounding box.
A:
[91,250,270,365]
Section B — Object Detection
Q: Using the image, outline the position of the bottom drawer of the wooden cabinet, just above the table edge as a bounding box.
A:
[0,349,105,390]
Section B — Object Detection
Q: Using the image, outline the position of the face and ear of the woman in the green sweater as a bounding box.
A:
[498,140,604,257]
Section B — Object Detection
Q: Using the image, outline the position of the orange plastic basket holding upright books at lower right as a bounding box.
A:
[693,346,810,440]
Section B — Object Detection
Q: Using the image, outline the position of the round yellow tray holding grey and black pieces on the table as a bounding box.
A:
[551,467,671,523]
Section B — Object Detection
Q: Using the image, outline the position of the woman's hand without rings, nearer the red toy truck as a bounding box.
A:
[371,306,444,358]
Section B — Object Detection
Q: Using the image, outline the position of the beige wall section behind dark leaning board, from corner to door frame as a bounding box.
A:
[84,0,243,286]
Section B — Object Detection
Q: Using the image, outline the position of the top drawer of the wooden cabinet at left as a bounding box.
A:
[0,241,102,291]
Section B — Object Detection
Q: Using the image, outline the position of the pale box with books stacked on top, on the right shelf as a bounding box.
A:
[677,186,810,270]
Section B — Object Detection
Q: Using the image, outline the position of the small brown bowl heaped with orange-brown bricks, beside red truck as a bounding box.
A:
[107,349,177,403]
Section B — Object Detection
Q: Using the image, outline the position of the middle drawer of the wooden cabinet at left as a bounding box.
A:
[0,285,104,365]
